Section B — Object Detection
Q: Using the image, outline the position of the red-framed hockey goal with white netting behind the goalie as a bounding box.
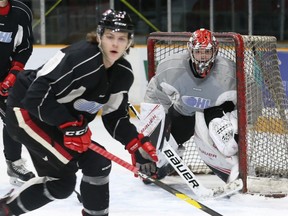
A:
[147,32,288,197]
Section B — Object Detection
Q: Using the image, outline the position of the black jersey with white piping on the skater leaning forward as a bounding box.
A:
[7,41,138,145]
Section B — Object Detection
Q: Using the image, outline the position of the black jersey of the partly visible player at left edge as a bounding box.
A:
[0,0,33,82]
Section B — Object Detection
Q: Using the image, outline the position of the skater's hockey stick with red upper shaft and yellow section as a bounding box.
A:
[89,143,222,216]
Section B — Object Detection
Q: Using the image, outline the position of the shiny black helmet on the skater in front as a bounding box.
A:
[97,9,134,39]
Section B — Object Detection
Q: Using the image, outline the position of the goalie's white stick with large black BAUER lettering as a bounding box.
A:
[129,103,243,199]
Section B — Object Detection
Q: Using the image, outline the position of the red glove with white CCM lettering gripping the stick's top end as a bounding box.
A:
[59,115,92,153]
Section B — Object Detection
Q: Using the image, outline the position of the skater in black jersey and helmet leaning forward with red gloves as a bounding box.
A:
[0,10,158,216]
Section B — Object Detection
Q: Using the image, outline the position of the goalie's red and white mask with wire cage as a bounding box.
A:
[187,29,218,78]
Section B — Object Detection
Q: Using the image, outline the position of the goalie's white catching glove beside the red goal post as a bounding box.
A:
[208,113,238,156]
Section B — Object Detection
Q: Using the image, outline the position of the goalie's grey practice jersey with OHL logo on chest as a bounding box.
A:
[144,53,236,116]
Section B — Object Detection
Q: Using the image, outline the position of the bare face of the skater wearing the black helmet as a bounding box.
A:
[101,29,129,67]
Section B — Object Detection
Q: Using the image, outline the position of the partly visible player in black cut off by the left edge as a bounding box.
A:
[0,0,35,185]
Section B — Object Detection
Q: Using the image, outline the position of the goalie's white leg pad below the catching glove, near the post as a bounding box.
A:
[194,112,239,182]
